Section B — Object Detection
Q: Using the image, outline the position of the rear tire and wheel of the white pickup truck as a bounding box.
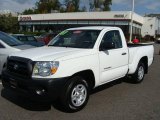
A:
[131,62,145,83]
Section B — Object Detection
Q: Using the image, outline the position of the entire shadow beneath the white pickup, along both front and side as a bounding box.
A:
[1,78,134,113]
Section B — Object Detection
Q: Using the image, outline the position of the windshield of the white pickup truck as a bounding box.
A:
[49,30,100,48]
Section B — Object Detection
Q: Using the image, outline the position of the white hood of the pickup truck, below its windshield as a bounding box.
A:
[11,46,92,61]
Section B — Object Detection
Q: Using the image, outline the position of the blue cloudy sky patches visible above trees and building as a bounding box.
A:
[0,0,160,15]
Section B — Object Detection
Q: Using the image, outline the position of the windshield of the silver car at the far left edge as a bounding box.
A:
[0,32,22,46]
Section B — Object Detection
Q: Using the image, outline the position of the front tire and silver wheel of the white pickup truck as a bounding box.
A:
[61,76,89,112]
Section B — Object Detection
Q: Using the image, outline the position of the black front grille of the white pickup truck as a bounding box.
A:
[7,57,32,78]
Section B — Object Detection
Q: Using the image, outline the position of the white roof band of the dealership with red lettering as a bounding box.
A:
[18,11,143,23]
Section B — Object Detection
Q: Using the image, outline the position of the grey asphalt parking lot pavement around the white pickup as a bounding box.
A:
[0,44,160,120]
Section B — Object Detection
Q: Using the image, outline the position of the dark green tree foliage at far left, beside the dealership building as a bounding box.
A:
[0,14,19,33]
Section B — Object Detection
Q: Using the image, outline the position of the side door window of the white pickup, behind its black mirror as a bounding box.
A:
[100,30,122,49]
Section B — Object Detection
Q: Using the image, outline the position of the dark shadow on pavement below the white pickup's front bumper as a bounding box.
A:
[1,89,51,111]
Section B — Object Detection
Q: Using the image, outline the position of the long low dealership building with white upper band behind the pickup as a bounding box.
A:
[18,11,144,38]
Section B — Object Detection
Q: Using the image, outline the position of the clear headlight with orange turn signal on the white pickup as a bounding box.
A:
[32,61,59,77]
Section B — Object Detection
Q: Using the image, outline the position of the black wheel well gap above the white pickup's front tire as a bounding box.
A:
[73,70,95,89]
